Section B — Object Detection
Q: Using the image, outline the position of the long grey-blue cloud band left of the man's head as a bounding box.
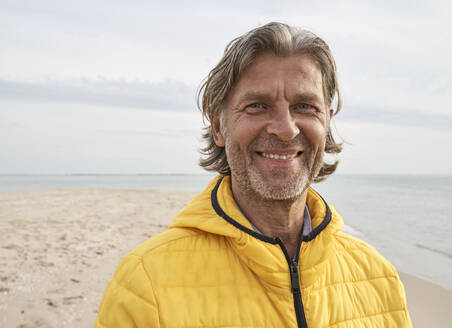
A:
[0,78,196,112]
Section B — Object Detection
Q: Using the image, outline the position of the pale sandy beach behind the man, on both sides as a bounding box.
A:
[0,189,452,328]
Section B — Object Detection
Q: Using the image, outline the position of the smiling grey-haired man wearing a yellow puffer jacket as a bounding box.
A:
[96,23,411,328]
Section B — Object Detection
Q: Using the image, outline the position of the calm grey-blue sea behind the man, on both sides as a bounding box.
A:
[0,174,452,290]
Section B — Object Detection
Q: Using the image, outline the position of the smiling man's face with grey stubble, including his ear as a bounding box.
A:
[212,54,332,200]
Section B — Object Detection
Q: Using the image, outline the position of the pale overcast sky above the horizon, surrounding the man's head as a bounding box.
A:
[0,0,452,174]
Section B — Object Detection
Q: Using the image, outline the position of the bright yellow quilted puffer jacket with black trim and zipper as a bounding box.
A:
[95,177,411,328]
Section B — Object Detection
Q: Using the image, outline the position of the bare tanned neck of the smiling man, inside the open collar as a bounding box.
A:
[231,179,307,258]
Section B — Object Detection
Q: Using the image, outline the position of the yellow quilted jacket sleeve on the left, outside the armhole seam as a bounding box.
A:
[94,254,160,328]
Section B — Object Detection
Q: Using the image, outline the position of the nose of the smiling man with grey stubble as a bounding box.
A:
[267,108,300,141]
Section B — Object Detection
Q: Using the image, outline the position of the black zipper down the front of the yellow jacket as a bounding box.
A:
[275,237,308,328]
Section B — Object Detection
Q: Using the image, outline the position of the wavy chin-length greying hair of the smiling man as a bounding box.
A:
[198,22,342,182]
